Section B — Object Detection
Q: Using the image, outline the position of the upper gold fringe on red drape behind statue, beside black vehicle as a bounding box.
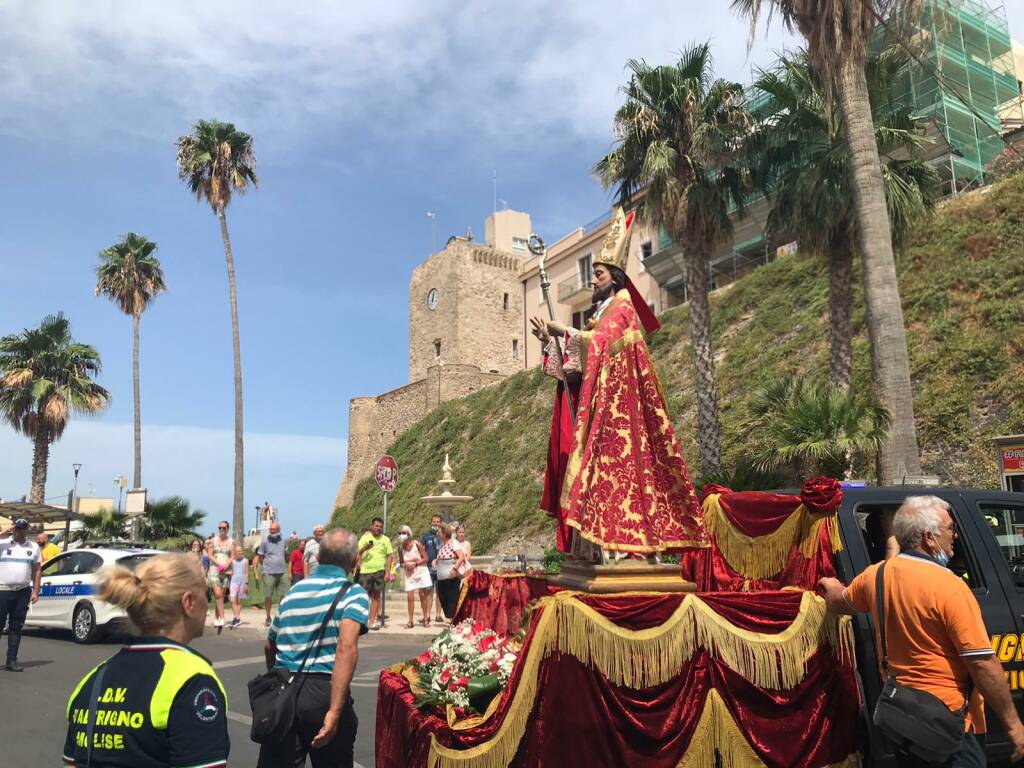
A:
[702,494,843,579]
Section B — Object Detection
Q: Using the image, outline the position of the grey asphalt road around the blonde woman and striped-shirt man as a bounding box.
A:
[0,627,430,768]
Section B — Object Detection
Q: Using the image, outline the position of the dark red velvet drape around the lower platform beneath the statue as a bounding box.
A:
[376,591,859,768]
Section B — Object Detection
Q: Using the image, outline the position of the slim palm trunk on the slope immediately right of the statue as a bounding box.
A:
[684,249,722,475]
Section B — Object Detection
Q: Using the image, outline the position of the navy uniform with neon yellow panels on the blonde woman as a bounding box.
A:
[63,637,229,768]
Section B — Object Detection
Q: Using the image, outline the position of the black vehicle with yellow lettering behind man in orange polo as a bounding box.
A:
[837,486,1024,766]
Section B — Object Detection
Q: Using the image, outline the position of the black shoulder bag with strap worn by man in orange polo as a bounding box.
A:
[872,562,971,764]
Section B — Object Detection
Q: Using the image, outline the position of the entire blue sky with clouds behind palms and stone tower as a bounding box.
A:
[0,0,1024,531]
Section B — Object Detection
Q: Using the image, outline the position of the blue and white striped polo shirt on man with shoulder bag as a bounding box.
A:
[267,563,370,675]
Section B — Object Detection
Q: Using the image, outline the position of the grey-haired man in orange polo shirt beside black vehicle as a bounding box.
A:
[818,496,1024,768]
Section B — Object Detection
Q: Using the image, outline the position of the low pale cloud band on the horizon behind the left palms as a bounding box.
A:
[0,421,346,531]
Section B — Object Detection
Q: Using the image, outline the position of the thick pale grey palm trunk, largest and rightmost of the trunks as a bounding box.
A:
[837,56,921,483]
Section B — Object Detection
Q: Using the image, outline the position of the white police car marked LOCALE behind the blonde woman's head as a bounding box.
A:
[25,547,161,643]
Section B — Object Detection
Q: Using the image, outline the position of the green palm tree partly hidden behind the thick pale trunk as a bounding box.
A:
[755,48,938,389]
